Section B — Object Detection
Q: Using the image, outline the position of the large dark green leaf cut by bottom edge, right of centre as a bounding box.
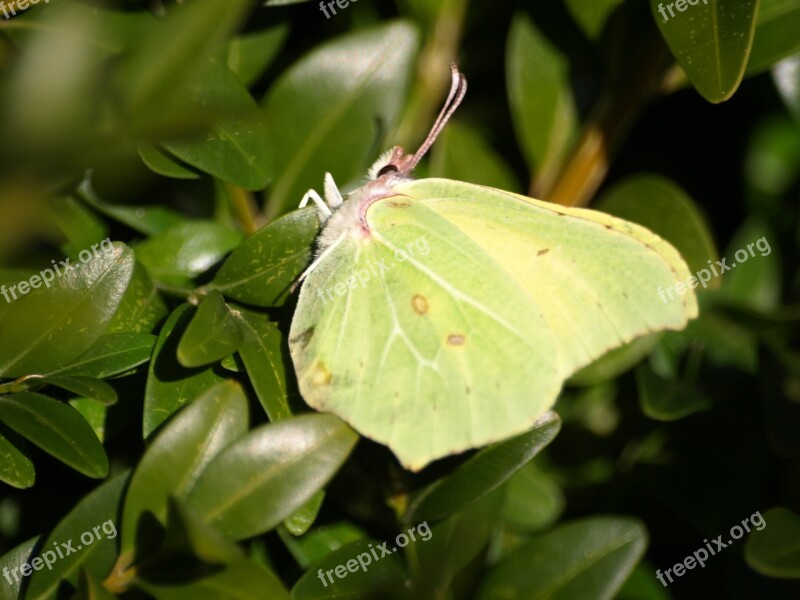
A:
[477,517,647,600]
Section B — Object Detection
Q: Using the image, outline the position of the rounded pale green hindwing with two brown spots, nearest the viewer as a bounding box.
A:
[289,197,563,469]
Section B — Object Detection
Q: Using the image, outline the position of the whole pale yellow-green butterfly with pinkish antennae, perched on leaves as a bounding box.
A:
[289,66,697,471]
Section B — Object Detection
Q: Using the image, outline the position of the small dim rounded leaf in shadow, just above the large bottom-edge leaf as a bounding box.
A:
[503,462,564,532]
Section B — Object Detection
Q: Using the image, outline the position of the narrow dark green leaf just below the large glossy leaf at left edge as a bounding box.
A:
[46,333,156,380]
